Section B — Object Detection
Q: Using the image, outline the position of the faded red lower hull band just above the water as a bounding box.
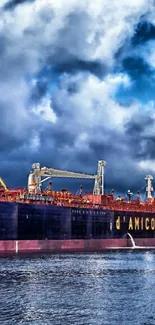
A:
[0,238,155,254]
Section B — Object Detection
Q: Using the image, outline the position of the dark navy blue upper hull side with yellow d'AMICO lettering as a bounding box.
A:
[0,202,155,240]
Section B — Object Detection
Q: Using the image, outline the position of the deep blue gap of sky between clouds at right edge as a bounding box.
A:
[115,19,155,102]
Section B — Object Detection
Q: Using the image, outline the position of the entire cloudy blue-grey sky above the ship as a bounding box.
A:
[0,0,155,193]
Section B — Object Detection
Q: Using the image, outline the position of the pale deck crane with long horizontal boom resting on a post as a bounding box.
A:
[28,160,106,195]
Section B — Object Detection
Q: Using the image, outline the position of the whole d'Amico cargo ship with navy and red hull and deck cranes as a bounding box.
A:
[0,160,155,254]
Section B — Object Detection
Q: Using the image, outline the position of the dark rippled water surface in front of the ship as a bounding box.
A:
[0,251,155,325]
